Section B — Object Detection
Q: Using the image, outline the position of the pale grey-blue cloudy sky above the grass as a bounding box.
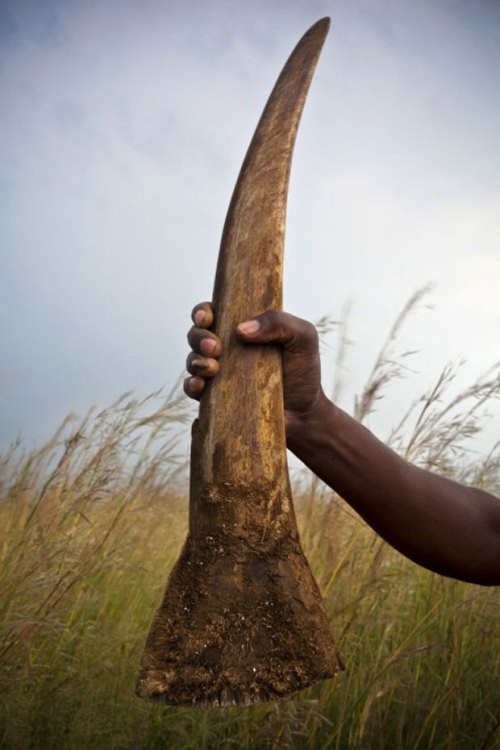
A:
[0,0,500,456]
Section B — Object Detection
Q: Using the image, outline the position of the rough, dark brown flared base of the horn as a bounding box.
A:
[136,536,343,707]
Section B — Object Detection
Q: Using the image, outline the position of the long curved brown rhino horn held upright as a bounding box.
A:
[137,18,342,706]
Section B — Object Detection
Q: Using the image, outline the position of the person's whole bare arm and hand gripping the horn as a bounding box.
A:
[184,302,500,586]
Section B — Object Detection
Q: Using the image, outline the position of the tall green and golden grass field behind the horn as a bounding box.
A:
[0,295,500,750]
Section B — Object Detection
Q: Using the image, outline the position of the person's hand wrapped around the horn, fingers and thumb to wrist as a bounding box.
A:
[184,302,323,430]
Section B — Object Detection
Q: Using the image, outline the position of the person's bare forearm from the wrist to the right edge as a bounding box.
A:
[288,397,500,585]
